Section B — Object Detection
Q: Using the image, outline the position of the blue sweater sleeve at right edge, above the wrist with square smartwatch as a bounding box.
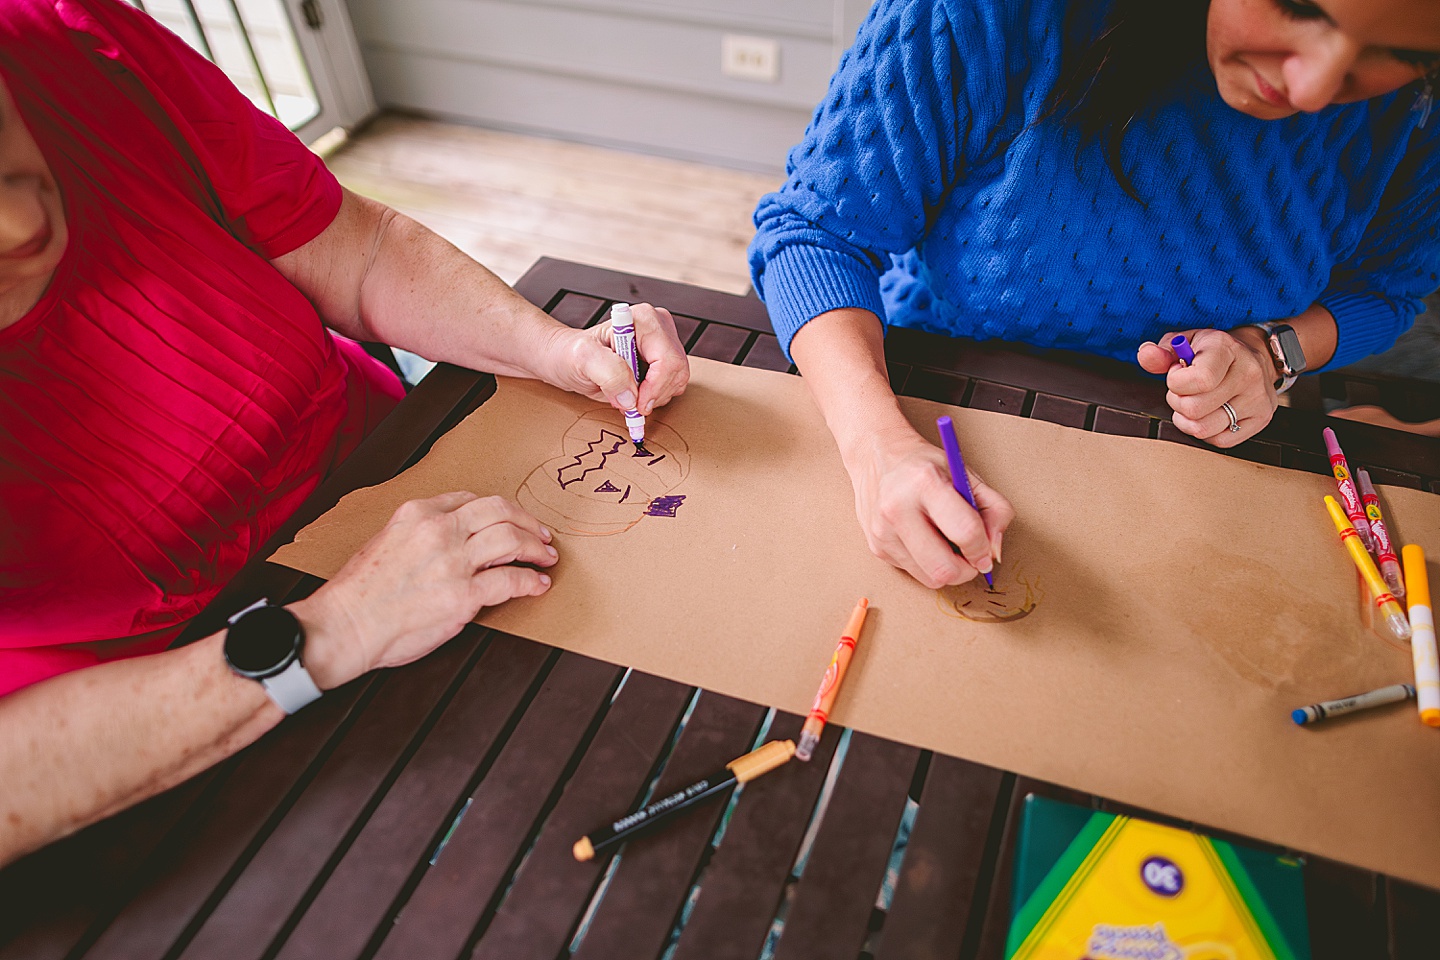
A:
[1319,128,1440,370]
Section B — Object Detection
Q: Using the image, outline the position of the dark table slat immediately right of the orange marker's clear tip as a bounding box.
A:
[775,733,920,960]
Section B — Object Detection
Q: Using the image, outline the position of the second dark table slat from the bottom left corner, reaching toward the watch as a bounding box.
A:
[73,676,376,957]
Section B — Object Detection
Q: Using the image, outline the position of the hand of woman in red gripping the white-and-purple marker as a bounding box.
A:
[546,304,690,416]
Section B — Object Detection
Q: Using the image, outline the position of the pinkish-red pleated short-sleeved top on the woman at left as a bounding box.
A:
[0,0,400,695]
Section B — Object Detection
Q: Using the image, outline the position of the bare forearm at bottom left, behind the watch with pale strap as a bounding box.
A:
[0,635,284,865]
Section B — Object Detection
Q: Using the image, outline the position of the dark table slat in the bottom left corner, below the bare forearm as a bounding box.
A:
[0,764,218,960]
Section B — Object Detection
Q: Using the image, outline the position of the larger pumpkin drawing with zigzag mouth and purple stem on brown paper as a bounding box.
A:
[516,409,690,537]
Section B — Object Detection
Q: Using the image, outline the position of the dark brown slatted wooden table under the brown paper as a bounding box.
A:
[0,261,1440,960]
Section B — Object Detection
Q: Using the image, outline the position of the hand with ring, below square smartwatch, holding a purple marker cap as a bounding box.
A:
[1135,327,1279,448]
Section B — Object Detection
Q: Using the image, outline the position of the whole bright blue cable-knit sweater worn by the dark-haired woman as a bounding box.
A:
[750,0,1440,366]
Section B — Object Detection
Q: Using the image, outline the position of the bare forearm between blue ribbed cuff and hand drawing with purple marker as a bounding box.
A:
[791,308,914,465]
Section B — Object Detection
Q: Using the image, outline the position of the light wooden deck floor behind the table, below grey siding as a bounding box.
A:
[330,115,778,294]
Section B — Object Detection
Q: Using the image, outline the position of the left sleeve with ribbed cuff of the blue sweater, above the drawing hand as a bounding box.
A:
[749,0,984,354]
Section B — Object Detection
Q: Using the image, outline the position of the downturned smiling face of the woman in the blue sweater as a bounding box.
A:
[1205,0,1440,119]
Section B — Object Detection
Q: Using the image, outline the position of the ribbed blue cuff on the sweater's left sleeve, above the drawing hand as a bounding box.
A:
[759,245,886,361]
